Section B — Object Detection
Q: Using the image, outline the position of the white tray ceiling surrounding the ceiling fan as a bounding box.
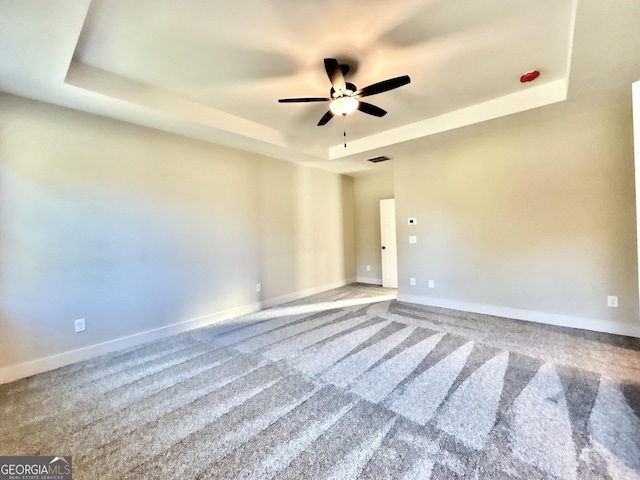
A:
[0,0,640,174]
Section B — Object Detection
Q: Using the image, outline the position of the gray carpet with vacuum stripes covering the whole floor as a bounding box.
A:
[0,285,640,480]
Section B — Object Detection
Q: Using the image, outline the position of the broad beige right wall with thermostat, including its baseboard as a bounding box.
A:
[394,99,640,335]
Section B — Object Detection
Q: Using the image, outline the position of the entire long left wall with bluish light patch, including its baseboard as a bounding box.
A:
[0,94,355,379]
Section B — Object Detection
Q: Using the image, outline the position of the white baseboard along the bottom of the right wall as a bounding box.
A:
[398,293,640,338]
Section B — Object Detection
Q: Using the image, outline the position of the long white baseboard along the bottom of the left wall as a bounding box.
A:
[0,278,356,385]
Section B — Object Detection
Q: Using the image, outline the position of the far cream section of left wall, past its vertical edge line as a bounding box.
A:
[259,158,355,305]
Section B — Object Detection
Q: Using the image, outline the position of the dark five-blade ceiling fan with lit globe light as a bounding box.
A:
[278,58,411,126]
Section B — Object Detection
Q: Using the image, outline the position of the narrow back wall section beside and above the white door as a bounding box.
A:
[354,170,393,285]
